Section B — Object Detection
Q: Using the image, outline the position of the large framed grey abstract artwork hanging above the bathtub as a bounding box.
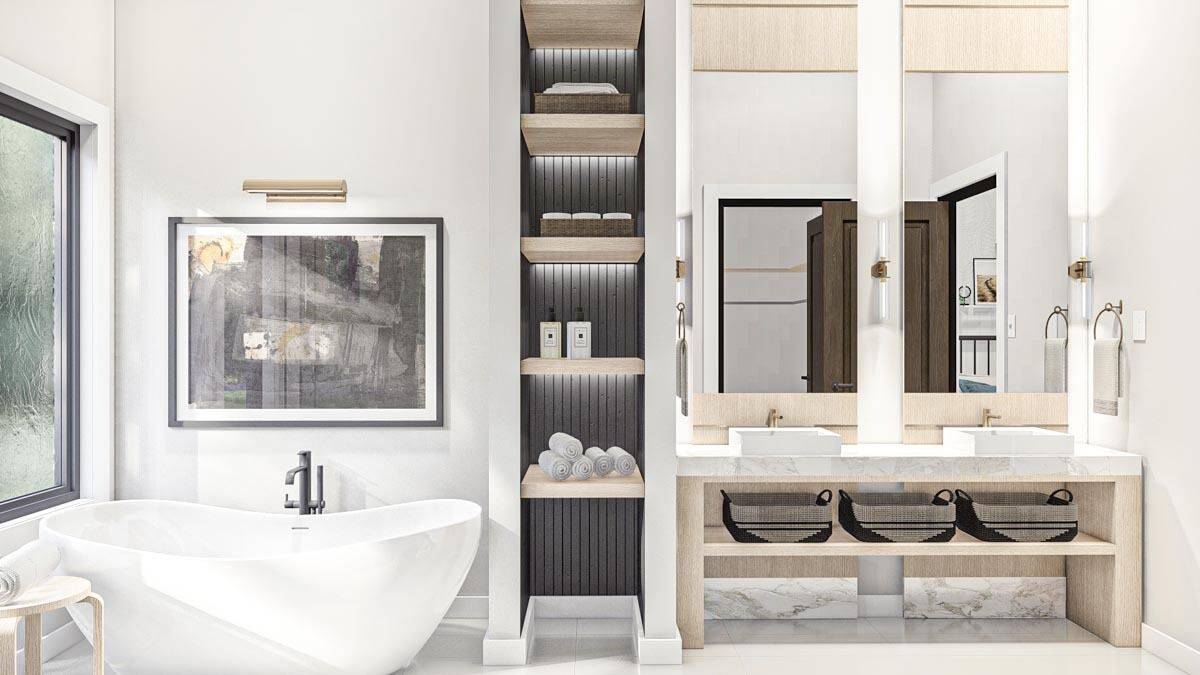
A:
[168,217,444,426]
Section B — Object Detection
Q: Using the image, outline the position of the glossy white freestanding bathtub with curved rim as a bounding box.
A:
[41,500,480,675]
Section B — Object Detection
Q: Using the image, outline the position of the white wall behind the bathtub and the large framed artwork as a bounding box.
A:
[116,0,490,595]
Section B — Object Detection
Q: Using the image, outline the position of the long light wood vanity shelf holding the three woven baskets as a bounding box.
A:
[704,525,1117,557]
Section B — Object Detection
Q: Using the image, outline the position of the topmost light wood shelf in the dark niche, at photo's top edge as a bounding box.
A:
[521,0,644,49]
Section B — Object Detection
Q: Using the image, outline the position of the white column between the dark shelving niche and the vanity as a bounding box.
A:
[638,1,683,663]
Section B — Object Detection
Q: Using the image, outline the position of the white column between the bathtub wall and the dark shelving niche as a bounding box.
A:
[482,0,526,665]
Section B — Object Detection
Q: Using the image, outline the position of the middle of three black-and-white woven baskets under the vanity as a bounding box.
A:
[838,490,954,542]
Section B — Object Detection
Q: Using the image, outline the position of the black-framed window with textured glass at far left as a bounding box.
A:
[0,90,79,521]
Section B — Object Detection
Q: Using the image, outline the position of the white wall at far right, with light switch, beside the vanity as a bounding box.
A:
[1088,0,1200,650]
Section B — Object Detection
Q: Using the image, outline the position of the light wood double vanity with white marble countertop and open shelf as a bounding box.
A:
[677,444,1141,649]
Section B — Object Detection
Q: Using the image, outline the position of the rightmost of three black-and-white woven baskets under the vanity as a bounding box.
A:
[954,489,1079,542]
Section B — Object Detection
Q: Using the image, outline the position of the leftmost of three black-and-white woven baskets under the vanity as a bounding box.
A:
[721,490,833,544]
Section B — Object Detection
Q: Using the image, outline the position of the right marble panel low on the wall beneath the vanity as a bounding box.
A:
[904,577,1067,619]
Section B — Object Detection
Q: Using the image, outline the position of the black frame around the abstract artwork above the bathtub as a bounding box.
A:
[167,216,445,429]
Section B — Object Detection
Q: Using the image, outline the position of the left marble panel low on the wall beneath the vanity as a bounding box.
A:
[704,578,858,619]
